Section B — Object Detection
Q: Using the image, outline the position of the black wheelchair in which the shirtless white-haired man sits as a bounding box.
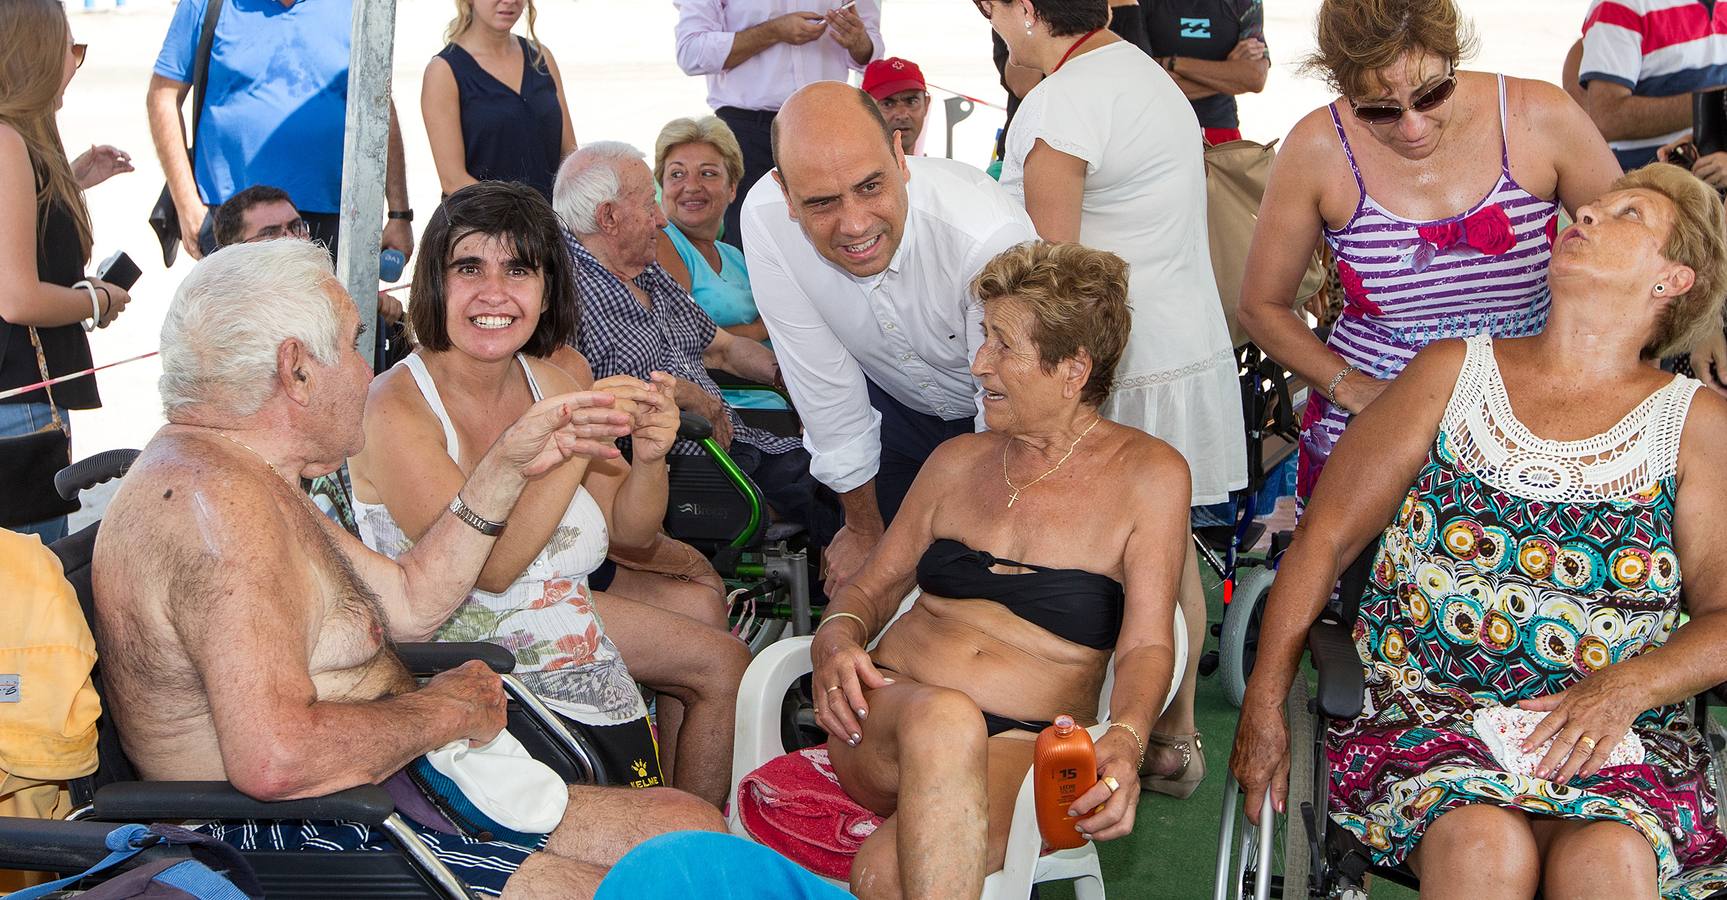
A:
[0,449,606,900]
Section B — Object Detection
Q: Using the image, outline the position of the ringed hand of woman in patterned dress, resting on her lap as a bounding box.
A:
[1518,667,1648,784]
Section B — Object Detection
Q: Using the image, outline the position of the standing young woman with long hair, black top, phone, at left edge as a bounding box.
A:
[0,0,131,541]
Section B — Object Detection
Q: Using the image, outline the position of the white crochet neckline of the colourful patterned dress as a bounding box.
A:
[1442,333,1701,503]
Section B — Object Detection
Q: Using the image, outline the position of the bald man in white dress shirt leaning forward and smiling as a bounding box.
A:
[743,81,1038,596]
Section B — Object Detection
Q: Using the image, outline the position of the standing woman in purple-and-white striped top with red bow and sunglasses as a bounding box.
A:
[1238,0,1620,501]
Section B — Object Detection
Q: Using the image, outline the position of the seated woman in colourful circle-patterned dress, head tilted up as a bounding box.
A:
[1231,164,1727,900]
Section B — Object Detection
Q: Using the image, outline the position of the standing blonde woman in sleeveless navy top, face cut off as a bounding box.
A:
[420,0,575,200]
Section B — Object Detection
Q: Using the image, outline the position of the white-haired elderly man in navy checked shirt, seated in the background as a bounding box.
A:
[553,142,843,546]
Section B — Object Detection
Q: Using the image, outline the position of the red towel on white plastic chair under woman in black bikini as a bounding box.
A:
[737,745,882,881]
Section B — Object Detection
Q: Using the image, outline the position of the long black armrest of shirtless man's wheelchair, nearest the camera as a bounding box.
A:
[95,781,395,826]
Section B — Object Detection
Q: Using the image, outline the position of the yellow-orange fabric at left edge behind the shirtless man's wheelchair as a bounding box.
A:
[0,529,102,781]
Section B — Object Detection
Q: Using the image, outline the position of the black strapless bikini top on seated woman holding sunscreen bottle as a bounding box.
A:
[917,537,1126,650]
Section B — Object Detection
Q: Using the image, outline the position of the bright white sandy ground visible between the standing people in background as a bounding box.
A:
[60,0,1587,518]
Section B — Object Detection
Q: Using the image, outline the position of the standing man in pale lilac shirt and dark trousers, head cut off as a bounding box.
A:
[674,0,881,247]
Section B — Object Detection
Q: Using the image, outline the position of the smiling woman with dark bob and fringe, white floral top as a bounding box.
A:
[349,181,750,803]
